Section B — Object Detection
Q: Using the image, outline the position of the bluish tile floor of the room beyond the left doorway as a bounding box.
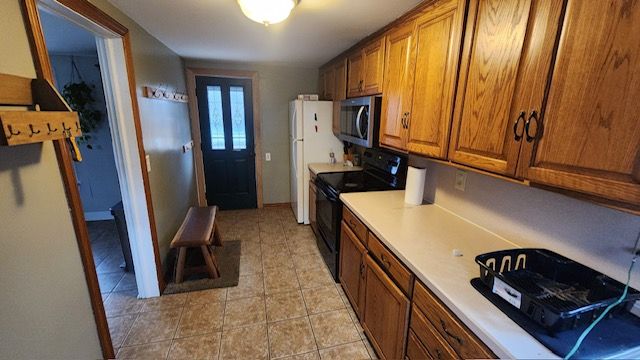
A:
[87,220,137,299]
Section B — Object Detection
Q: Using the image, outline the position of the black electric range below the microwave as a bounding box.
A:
[315,149,407,281]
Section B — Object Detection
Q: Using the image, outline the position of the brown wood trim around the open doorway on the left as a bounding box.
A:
[21,0,166,359]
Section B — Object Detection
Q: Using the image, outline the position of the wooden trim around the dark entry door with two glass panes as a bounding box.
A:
[186,67,264,208]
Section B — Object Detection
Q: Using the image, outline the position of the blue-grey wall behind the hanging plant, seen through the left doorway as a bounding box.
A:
[50,53,121,220]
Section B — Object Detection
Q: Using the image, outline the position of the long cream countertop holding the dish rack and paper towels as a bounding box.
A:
[340,191,558,359]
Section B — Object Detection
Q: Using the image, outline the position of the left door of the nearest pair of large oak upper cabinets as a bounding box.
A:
[449,0,564,176]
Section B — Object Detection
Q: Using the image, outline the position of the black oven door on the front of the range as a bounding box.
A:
[316,184,342,281]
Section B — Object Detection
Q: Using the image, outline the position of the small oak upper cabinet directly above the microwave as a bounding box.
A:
[347,37,385,97]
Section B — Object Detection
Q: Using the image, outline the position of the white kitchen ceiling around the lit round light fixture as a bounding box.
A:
[109,0,420,67]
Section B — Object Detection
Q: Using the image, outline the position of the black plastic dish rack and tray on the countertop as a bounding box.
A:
[476,249,640,332]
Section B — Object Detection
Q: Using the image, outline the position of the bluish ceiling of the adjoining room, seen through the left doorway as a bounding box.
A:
[40,11,97,55]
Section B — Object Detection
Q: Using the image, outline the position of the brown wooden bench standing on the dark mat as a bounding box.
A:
[171,206,222,284]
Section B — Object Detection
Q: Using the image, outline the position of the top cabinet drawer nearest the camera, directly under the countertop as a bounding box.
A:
[413,281,495,359]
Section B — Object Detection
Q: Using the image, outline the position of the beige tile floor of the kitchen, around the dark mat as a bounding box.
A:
[105,208,375,359]
